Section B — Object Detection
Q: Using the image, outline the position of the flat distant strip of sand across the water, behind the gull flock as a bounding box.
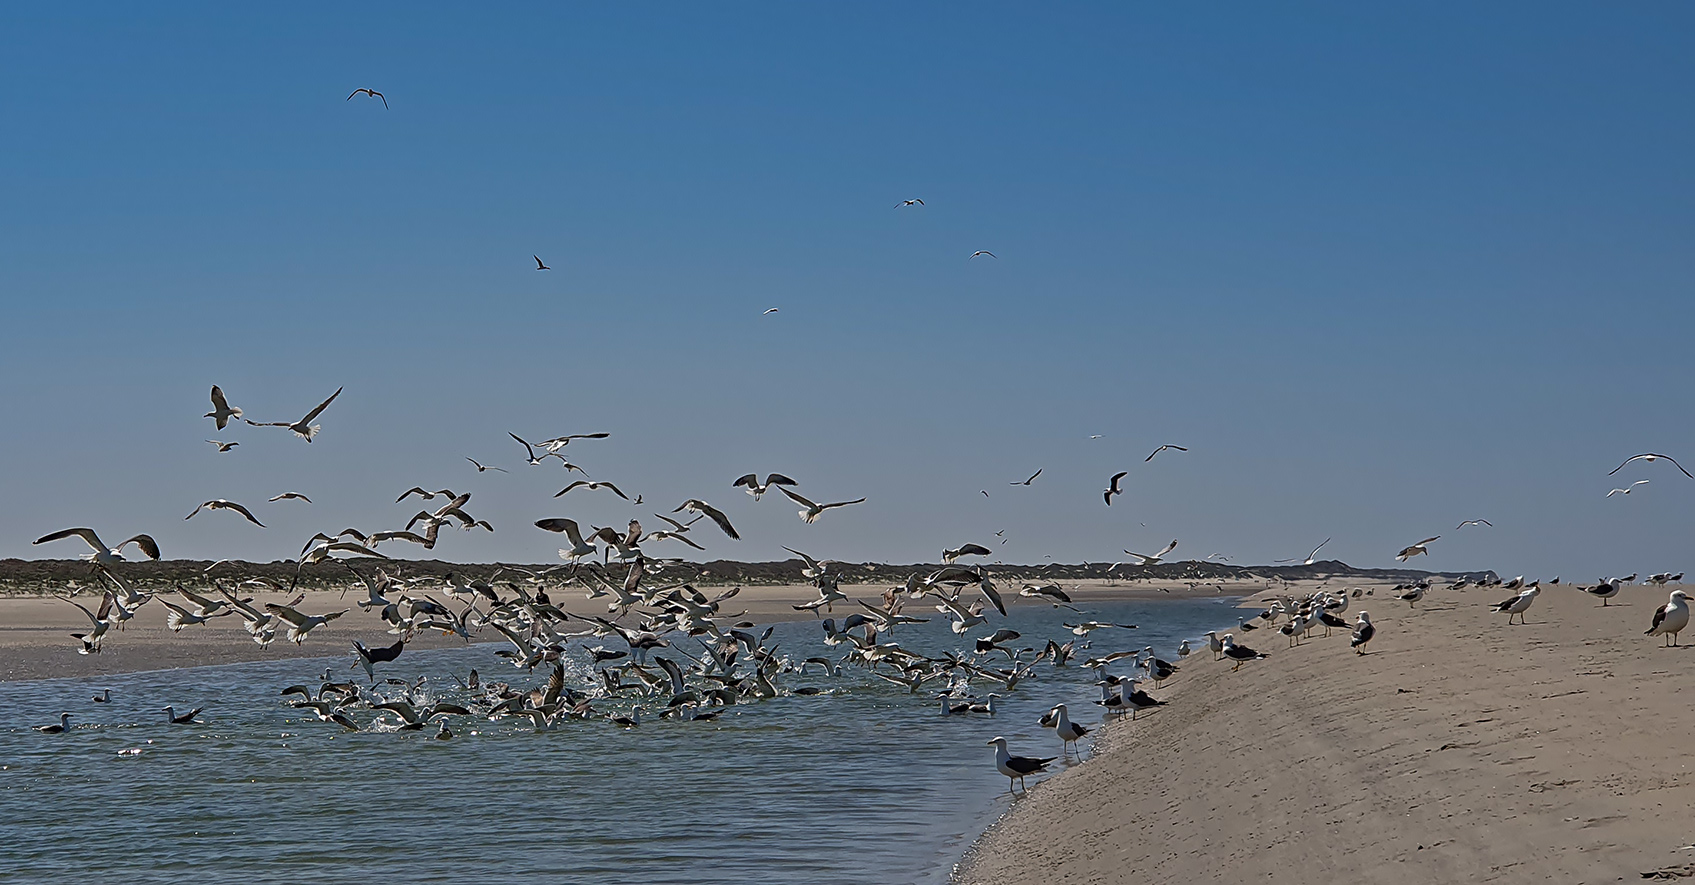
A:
[0,582,1251,682]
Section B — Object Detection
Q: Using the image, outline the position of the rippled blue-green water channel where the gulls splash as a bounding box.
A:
[0,598,1234,885]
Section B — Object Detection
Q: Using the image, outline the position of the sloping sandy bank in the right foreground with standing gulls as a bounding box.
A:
[958,587,1695,885]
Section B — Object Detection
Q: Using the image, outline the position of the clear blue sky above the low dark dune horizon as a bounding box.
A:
[0,2,1695,580]
